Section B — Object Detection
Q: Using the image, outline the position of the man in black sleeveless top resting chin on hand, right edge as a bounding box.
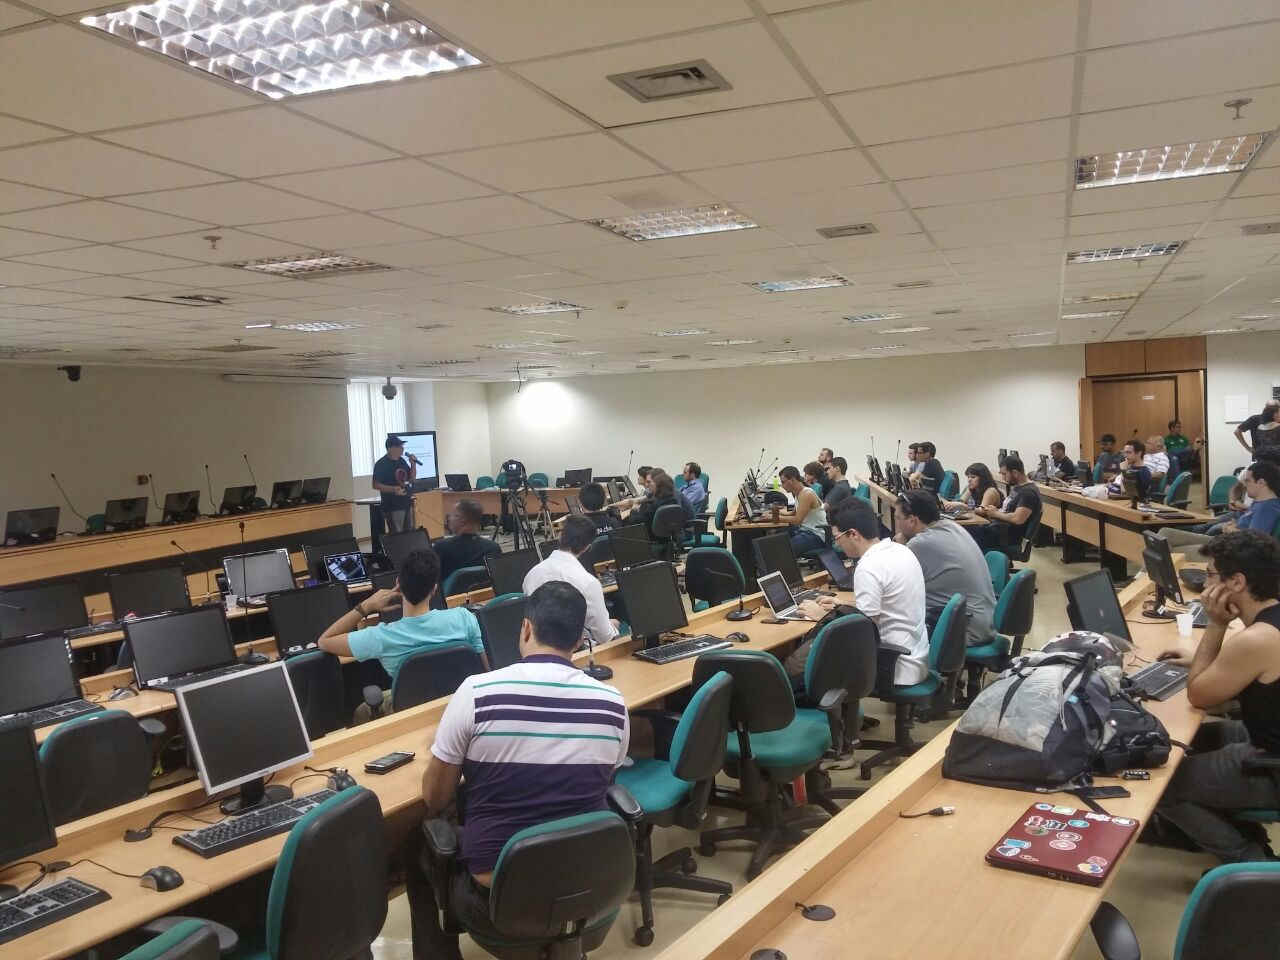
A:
[1157,530,1280,863]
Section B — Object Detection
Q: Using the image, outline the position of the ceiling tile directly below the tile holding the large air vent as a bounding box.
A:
[617,100,849,170]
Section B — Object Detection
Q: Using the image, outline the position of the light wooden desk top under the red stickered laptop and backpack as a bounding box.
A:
[658,576,1202,960]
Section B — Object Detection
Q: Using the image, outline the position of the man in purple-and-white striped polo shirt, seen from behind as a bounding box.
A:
[407,580,630,960]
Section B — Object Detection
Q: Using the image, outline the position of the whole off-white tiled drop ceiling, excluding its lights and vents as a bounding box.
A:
[0,0,1280,380]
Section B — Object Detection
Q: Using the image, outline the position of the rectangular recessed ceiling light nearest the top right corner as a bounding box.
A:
[1075,133,1266,189]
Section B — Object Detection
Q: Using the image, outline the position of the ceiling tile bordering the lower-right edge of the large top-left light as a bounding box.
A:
[297,69,591,154]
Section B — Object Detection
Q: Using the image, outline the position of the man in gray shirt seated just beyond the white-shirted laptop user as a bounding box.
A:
[893,490,996,646]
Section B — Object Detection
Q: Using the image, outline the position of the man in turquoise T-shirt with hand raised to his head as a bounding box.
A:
[320,550,489,723]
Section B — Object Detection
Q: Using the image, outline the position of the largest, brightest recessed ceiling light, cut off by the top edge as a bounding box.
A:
[81,0,480,100]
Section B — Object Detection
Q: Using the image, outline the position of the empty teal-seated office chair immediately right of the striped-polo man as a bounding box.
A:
[616,671,733,947]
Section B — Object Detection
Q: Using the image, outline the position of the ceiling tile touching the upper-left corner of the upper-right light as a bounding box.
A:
[832,56,1074,143]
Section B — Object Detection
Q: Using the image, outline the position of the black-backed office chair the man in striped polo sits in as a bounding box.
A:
[422,787,639,960]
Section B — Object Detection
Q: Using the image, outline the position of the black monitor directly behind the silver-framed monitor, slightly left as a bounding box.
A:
[124,603,236,689]
